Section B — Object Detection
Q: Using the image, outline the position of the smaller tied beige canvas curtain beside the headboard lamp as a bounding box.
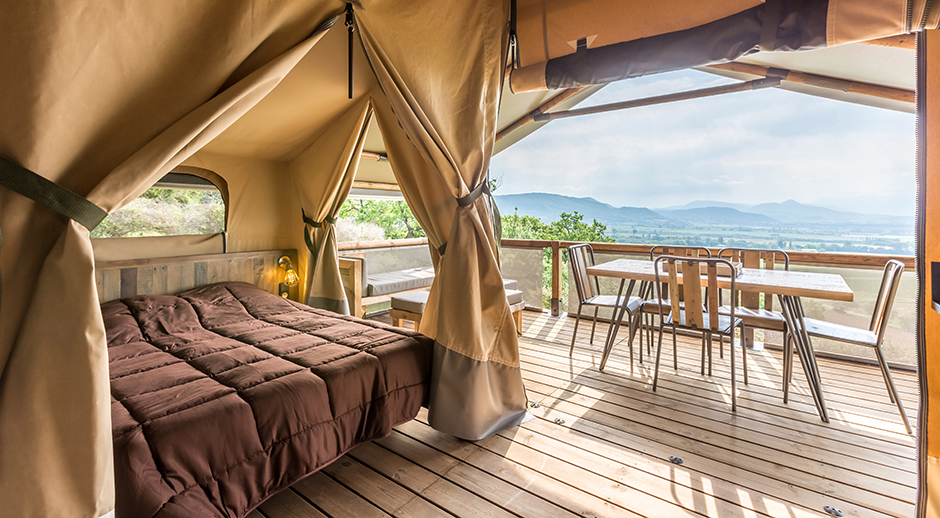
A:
[290,96,372,315]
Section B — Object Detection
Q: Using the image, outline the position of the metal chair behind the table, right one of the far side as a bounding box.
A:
[718,247,790,364]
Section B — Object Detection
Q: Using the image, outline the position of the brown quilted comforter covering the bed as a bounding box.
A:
[101,283,432,518]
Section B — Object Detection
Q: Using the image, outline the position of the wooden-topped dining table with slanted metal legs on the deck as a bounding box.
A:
[587,259,855,423]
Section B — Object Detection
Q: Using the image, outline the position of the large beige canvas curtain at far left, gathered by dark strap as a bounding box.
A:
[0,1,342,517]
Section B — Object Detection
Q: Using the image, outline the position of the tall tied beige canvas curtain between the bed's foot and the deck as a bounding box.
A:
[356,0,526,440]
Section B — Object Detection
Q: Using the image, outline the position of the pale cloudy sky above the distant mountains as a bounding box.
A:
[490,70,916,215]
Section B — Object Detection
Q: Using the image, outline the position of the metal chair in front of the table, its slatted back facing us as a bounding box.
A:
[653,255,747,412]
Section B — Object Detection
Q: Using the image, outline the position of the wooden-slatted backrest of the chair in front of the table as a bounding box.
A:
[653,255,735,332]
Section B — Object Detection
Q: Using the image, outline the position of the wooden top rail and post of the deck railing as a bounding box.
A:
[339,237,915,316]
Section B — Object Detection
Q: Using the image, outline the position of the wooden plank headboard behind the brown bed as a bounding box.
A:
[95,249,298,302]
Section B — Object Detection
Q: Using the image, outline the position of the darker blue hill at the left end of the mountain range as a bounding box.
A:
[494,192,668,225]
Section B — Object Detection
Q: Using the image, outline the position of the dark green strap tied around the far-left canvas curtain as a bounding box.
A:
[0,157,108,230]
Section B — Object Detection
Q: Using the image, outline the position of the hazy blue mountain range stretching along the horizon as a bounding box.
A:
[494,193,912,227]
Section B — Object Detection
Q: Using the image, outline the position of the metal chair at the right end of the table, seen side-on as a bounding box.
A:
[800,259,913,433]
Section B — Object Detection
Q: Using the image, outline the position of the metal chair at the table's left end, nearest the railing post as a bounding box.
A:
[568,243,643,370]
